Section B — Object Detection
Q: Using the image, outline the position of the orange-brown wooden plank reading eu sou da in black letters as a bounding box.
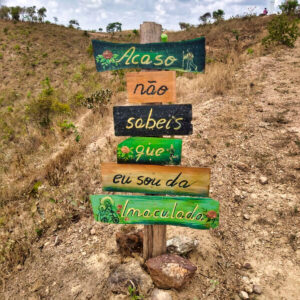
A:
[101,163,210,197]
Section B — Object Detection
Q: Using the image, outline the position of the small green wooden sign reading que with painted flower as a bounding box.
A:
[117,137,182,165]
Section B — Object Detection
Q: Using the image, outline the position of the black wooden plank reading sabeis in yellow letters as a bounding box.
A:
[113,104,193,137]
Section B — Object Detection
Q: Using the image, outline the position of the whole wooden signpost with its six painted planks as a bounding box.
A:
[90,22,219,259]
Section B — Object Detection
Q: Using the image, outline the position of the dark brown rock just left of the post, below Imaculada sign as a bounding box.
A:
[116,229,143,256]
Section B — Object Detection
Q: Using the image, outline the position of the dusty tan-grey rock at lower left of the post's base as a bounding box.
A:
[107,259,153,296]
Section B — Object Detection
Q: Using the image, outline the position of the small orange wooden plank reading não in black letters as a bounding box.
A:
[126,71,176,103]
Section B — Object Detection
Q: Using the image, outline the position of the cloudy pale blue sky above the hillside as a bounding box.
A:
[0,0,281,31]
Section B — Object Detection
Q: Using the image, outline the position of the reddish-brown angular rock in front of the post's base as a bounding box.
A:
[146,254,197,289]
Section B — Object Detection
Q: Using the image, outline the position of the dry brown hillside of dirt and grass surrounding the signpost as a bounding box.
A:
[0,19,300,299]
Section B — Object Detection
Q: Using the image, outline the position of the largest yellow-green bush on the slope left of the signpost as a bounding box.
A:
[26,77,70,128]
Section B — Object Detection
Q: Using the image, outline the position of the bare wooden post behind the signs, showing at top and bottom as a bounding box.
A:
[140,22,167,259]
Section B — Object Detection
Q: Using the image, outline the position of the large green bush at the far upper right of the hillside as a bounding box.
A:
[262,14,299,47]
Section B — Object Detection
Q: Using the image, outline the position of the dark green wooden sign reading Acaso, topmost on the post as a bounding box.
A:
[92,37,205,72]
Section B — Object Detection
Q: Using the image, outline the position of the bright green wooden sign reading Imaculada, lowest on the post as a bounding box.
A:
[90,195,219,229]
